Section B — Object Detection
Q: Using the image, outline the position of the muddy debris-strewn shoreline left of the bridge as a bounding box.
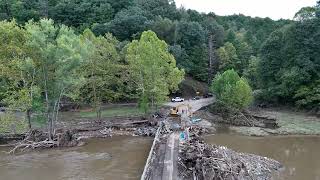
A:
[0,116,159,147]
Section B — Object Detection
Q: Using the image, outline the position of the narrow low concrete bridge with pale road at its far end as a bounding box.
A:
[141,98,214,180]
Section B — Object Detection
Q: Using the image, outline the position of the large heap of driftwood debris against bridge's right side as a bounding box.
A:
[178,138,282,180]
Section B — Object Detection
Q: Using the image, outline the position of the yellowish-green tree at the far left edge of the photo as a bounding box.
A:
[0,21,40,129]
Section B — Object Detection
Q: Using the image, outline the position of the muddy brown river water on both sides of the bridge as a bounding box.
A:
[0,134,320,180]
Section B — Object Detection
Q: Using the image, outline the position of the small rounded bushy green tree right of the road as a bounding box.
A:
[211,70,253,110]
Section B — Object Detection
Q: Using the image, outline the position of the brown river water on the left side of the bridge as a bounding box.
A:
[0,137,152,180]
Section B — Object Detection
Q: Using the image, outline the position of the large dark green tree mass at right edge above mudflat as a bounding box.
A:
[258,15,320,108]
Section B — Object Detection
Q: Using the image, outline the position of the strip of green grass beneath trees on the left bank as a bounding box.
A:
[80,107,144,118]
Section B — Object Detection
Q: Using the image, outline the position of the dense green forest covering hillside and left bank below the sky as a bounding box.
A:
[0,0,320,110]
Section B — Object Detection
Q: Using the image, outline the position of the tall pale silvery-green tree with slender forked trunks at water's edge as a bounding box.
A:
[25,19,89,140]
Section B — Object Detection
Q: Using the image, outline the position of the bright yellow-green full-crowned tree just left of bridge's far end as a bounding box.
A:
[126,31,184,112]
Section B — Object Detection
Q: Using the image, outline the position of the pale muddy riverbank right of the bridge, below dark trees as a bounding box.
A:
[195,109,320,136]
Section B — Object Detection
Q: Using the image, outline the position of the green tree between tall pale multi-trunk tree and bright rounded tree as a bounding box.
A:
[81,29,124,120]
